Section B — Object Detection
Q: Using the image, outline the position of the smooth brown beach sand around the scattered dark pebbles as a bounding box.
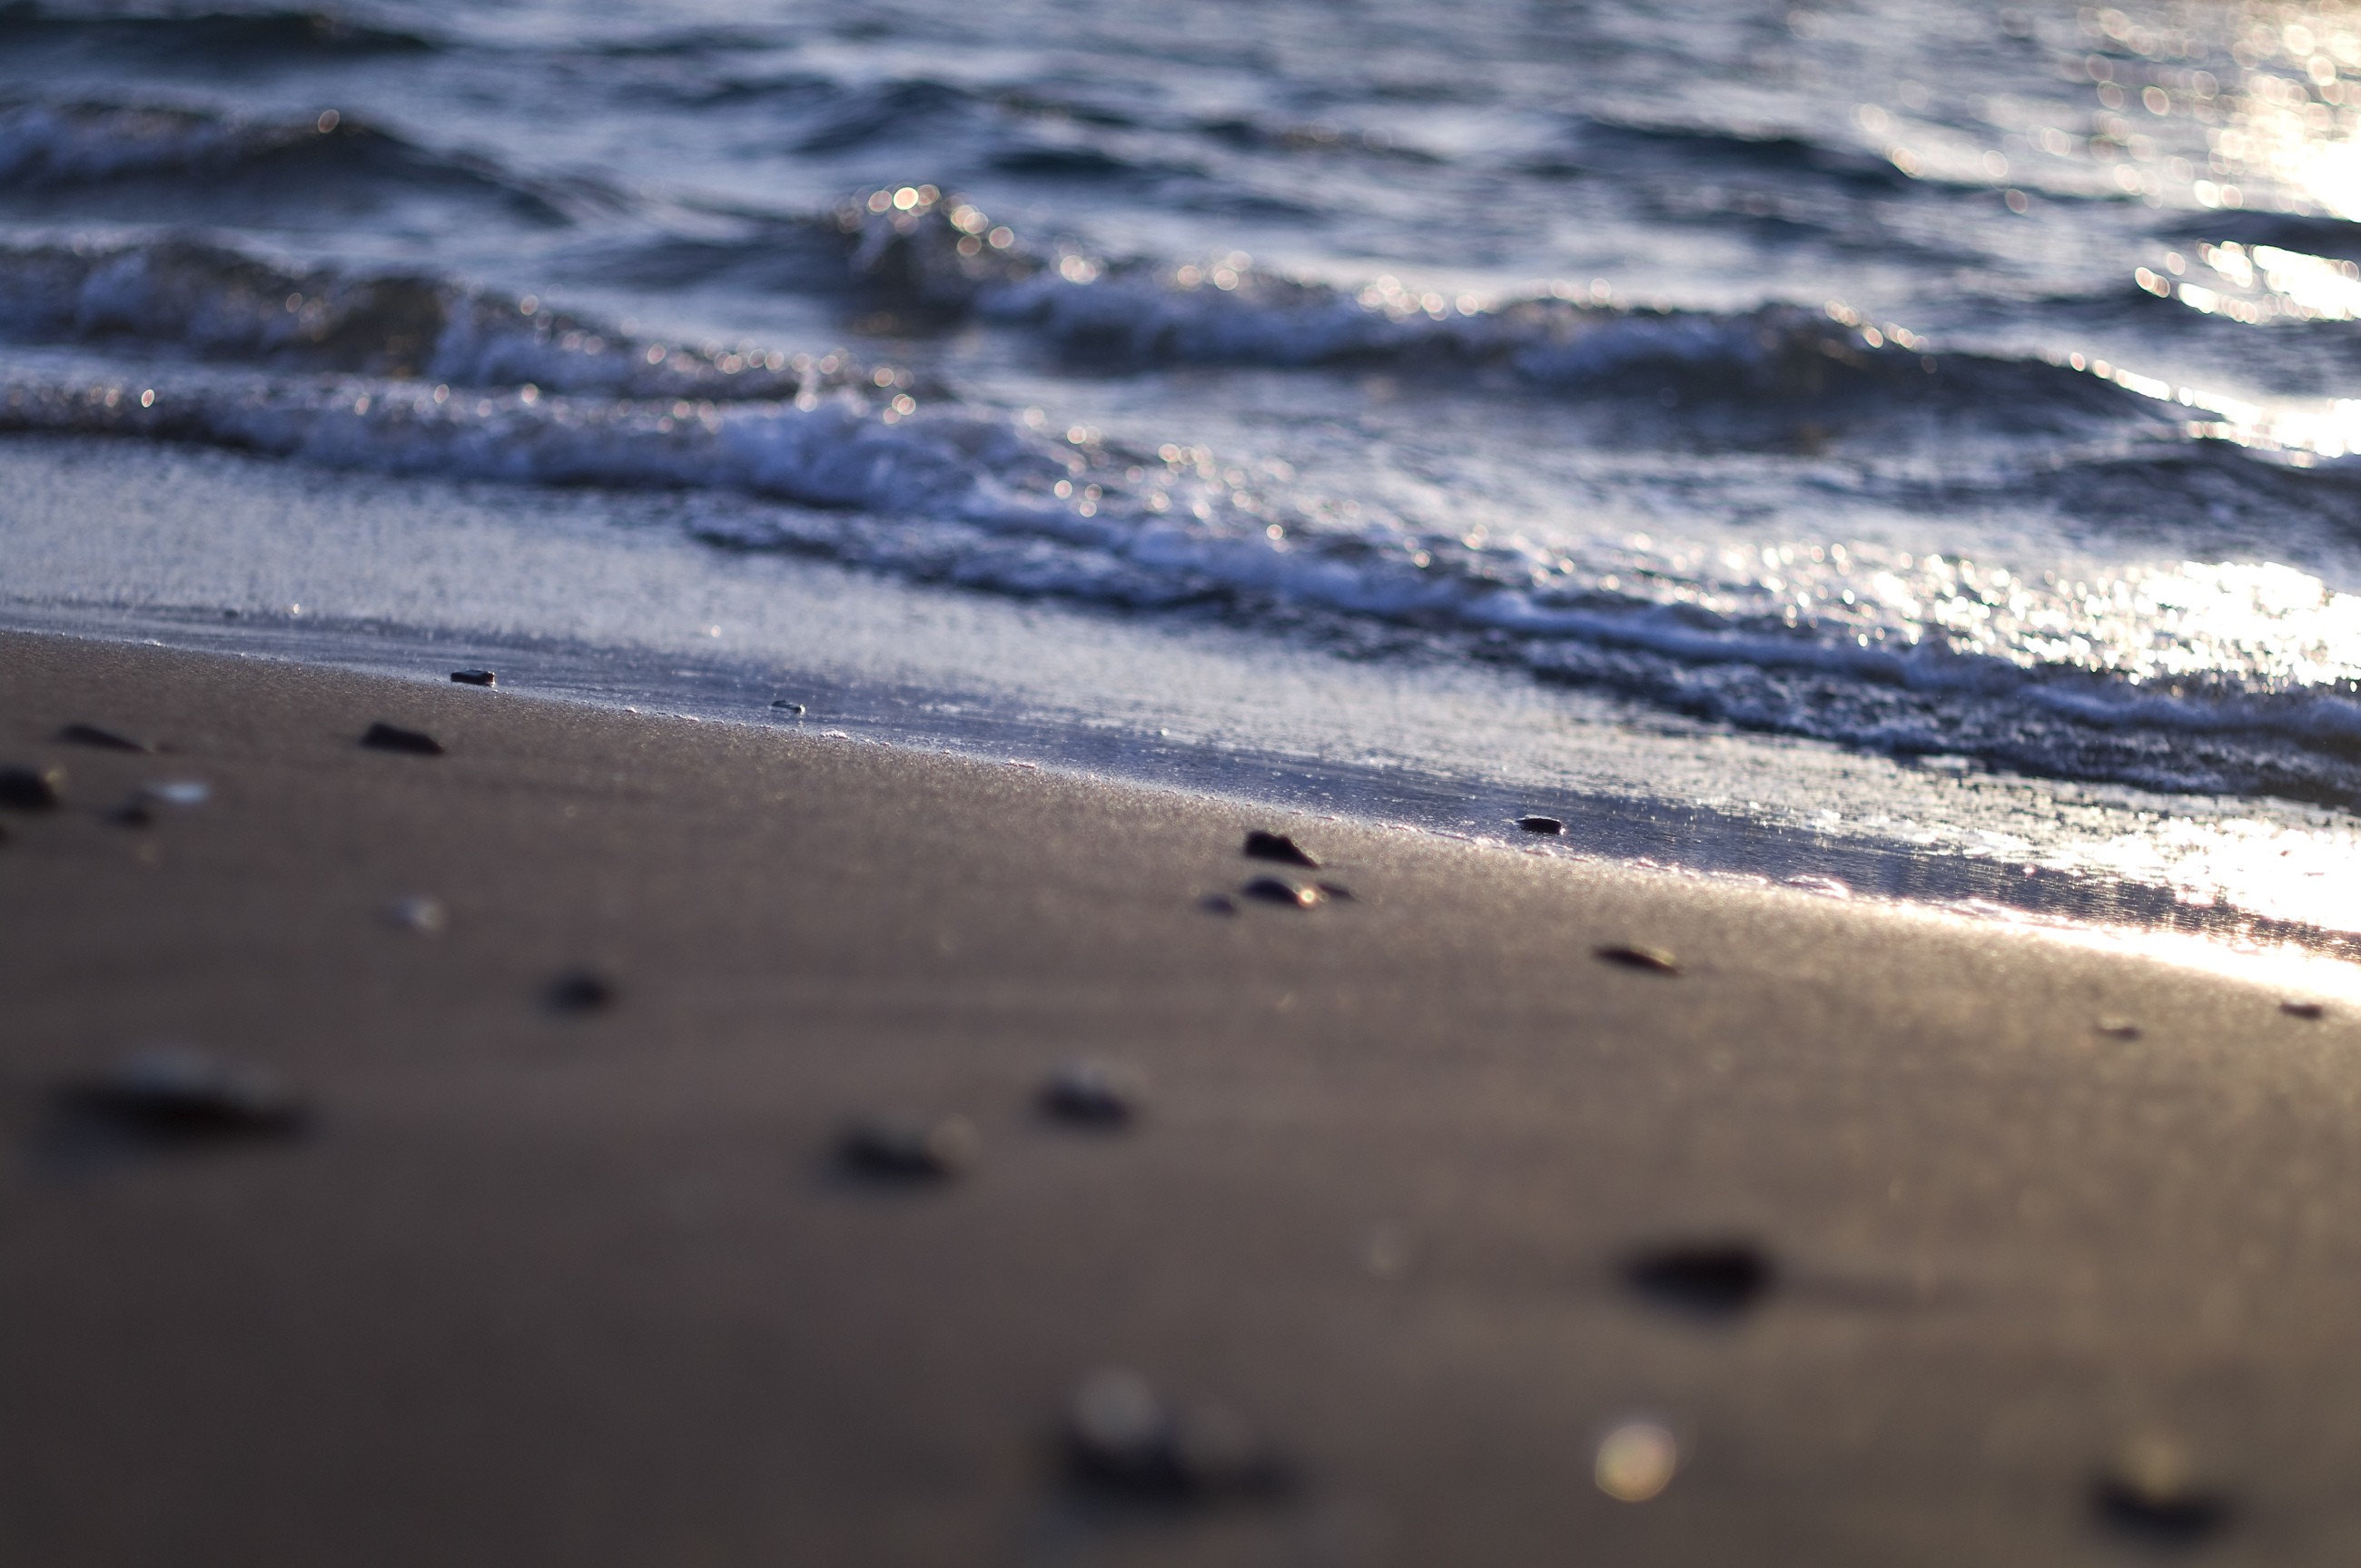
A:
[0,636,2361,1568]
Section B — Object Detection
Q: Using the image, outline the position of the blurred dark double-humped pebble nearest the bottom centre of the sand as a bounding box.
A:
[1065,1372,1289,1502]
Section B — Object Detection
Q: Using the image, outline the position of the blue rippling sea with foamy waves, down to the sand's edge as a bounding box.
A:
[0,0,2361,947]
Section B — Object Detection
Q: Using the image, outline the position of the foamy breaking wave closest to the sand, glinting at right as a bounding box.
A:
[14,342,2361,808]
